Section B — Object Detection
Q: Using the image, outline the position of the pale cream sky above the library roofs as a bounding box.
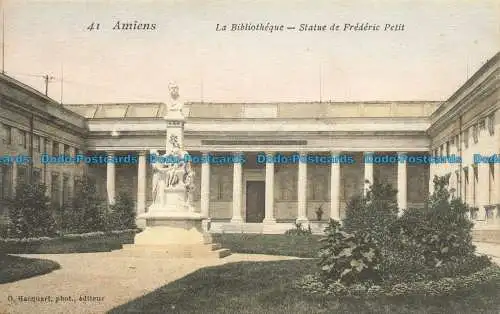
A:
[0,0,500,103]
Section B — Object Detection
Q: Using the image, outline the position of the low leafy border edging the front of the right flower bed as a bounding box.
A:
[297,265,500,298]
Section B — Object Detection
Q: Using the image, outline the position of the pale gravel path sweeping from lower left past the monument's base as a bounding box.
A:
[0,251,302,314]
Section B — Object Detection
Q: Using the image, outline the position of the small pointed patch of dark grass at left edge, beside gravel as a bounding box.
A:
[0,254,61,284]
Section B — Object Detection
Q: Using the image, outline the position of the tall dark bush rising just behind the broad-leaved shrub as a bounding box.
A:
[343,181,398,242]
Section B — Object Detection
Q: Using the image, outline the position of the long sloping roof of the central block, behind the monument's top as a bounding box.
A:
[64,101,441,119]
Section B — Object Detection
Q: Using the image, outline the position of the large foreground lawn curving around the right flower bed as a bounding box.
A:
[110,260,500,314]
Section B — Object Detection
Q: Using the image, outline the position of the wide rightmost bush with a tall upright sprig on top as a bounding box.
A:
[393,175,475,266]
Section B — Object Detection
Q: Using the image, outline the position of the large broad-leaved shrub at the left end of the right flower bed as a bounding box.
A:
[318,219,380,285]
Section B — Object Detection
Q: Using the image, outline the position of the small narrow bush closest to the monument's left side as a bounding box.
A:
[108,193,137,230]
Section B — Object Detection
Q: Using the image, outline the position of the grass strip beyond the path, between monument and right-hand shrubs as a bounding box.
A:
[213,233,321,257]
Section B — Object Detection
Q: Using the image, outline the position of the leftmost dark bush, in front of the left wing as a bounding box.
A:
[8,183,56,238]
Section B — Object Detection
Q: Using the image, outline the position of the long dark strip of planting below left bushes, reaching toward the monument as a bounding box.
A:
[0,229,138,254]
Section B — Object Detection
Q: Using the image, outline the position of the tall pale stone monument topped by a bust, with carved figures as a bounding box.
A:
[124,87,230,258]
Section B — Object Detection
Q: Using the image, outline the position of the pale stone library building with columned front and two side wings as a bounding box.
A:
[0,50,500,233]
